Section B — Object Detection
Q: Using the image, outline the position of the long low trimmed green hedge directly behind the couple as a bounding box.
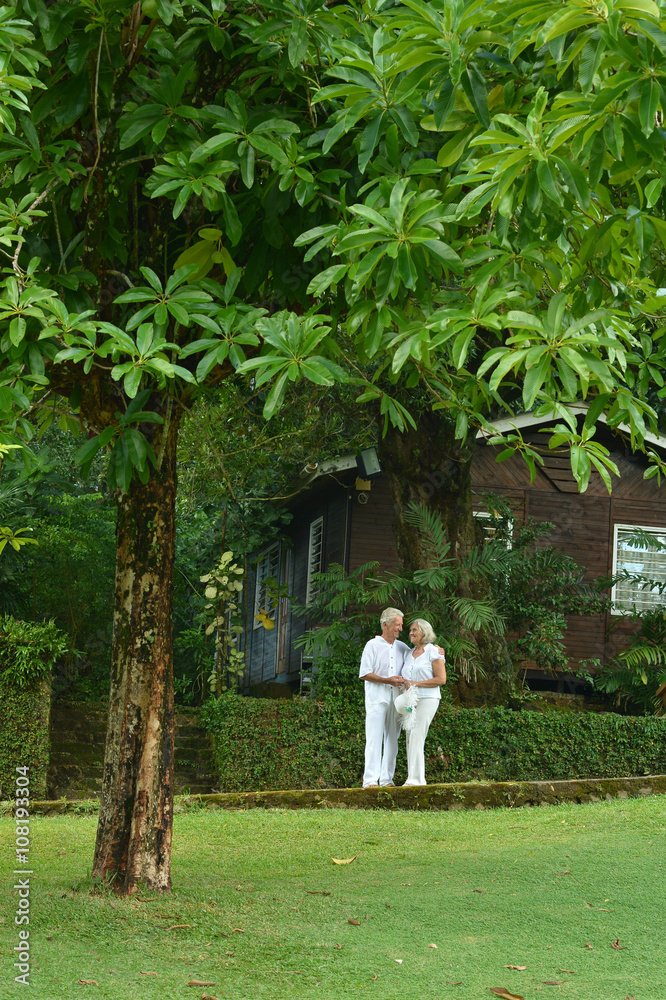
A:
[202,695,666,792]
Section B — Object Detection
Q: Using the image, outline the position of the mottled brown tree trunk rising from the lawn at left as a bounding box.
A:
[93,406,179,893]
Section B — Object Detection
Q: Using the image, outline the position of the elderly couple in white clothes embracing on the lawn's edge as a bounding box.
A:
[359,608,446,788]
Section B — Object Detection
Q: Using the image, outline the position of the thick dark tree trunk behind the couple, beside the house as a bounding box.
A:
[379,412,513,703]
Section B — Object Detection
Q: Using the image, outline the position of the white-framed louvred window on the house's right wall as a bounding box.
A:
[611,524,666,615]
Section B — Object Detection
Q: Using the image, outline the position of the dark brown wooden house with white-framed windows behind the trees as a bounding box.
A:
[244,411,666,690]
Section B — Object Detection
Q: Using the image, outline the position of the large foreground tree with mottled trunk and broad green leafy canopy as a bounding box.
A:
[0,0,666,891]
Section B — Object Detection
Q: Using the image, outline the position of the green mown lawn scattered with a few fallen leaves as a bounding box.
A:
[0,797,666,1000]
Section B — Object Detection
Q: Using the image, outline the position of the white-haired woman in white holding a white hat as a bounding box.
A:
[402,618,446,785]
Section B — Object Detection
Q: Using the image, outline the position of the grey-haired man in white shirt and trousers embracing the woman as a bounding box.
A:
[359,608,409,788]
